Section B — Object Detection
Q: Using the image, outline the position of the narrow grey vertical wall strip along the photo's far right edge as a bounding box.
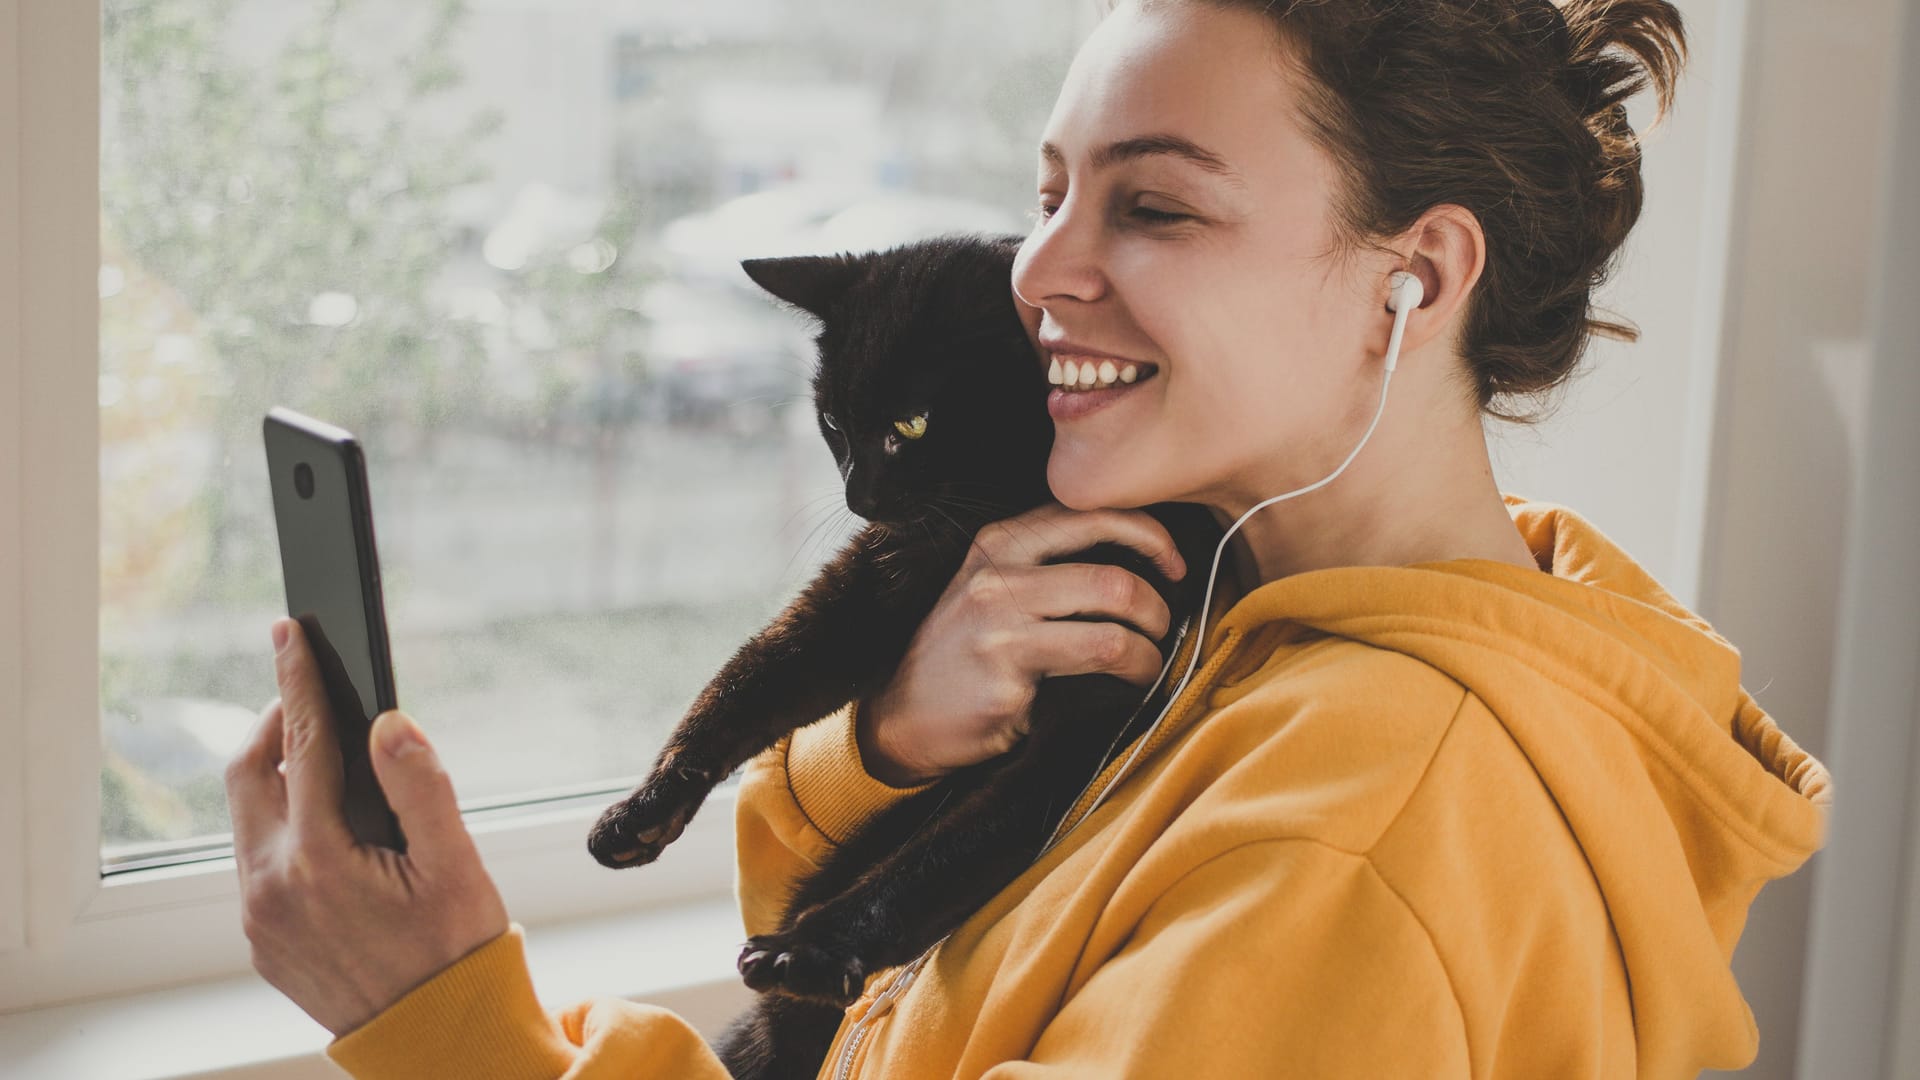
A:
[1799,6,1920,1076]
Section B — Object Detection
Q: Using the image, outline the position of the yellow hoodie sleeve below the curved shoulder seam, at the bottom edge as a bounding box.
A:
[985,840,1471,1080]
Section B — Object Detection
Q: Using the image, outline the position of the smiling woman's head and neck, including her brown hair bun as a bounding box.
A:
[1014,2,1684,580]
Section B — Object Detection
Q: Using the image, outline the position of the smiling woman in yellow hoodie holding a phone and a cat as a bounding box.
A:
[228,0,1830,1080]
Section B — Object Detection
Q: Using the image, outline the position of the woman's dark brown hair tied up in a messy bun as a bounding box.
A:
[1121,0,1686,423]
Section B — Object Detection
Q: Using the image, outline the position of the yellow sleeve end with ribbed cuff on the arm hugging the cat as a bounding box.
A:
[733,701,931,936]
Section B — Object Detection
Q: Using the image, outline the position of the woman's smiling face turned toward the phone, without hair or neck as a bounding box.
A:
[1014,2,1394,513]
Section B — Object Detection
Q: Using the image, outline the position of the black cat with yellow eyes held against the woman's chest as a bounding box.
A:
[588,236,1221,1080]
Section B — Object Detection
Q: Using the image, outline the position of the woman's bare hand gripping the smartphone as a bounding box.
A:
[227,619,518,1030]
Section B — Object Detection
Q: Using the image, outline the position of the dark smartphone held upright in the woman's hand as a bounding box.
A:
[261,405,407,851]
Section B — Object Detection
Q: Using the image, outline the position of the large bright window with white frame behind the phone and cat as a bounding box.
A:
[0,0,1096,1009]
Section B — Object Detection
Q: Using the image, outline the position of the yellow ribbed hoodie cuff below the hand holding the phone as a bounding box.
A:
[326,922,578,1080]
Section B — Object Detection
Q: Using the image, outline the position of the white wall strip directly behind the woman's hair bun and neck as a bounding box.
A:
[1488,0,1745,605]
